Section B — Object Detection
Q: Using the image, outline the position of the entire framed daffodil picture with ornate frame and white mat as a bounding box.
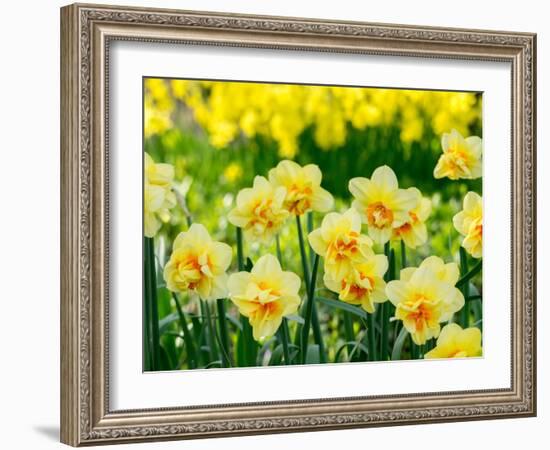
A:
[61,4,536,446]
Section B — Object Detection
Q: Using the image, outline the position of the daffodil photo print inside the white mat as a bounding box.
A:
[143,78,483,371]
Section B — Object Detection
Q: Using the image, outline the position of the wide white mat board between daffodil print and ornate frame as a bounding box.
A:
[109,42,511,410]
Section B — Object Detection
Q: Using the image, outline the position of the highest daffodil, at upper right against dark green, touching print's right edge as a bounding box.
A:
[434,130,482,180]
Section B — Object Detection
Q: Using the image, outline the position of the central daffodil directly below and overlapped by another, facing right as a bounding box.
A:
[324,253,388,314]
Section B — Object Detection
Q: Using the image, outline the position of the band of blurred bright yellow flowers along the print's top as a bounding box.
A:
[145,78,481,158]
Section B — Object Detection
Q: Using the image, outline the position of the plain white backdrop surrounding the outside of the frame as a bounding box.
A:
[0,0,550,449]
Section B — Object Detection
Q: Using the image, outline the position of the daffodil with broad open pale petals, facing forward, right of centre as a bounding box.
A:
[349,166,416,244]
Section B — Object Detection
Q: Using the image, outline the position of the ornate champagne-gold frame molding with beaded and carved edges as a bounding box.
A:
[61,4,536,446]
